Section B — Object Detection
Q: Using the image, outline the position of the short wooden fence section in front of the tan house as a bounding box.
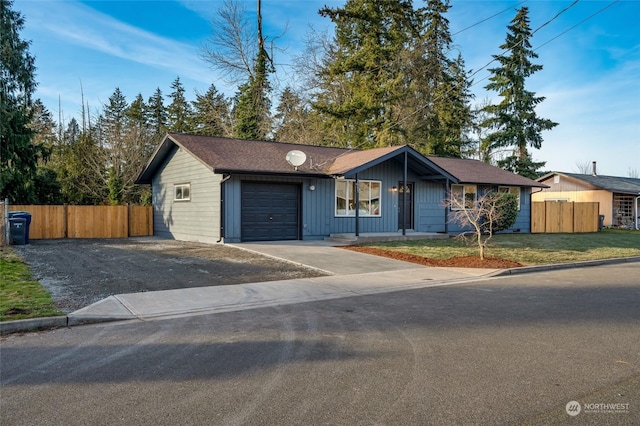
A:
[531,201,600,233]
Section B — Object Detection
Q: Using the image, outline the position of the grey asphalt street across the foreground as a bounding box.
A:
[0,263,640,425]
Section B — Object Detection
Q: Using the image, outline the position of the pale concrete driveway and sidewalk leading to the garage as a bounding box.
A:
[67,241,497,325]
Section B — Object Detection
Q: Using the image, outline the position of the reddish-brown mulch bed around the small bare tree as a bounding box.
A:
[342,246,522,269]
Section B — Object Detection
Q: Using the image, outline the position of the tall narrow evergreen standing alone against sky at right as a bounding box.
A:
[481,7,558,179]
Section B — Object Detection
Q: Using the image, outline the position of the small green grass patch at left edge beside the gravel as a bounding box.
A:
[0,247,64,321]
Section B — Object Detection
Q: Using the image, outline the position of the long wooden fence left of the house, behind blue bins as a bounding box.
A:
[9,205,153,240]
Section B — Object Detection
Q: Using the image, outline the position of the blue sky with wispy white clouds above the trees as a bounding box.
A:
[13,0,640,176]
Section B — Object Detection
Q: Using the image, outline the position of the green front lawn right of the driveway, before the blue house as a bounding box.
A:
[364,229,640,266]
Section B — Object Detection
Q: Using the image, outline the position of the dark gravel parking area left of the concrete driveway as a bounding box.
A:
[13,237,323,312]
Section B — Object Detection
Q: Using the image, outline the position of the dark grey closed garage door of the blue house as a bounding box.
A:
[241,182,300,241]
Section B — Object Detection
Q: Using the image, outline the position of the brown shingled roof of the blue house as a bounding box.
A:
[136,133,546,187]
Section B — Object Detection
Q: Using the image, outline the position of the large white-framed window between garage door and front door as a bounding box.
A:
[335,179,381,216]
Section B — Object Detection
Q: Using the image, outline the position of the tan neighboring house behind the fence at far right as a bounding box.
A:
[531,168,640,229]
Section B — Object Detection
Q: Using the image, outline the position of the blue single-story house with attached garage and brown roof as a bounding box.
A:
[137,134,545,242]
